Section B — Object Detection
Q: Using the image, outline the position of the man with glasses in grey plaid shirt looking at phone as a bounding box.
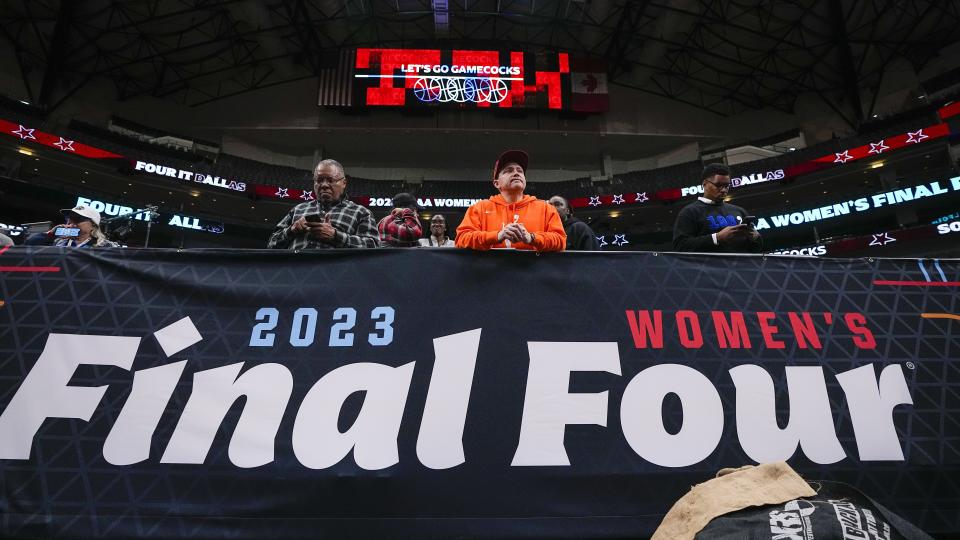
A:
[267,159,380,249]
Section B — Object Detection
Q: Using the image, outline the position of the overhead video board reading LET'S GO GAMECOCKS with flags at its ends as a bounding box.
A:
[320,49,607,112]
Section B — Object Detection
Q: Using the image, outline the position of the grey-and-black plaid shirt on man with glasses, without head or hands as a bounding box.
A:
[267,196,380,249]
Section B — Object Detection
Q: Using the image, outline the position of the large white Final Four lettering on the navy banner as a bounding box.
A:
[0,330,916,468]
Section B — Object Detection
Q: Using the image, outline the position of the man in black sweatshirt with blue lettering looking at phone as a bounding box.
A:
[673,163,763,253]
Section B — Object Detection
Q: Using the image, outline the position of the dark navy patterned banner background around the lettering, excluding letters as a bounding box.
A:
[0,248,960,538]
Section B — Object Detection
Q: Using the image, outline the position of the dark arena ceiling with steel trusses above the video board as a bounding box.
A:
[0,0,960,126]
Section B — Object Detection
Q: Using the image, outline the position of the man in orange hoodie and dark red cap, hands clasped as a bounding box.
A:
[457,150,567,251]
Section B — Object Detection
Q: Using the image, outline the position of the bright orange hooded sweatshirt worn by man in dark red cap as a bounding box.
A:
[457,195,567,251]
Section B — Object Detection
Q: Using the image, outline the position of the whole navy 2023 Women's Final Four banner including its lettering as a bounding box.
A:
[0,248,960,538]
